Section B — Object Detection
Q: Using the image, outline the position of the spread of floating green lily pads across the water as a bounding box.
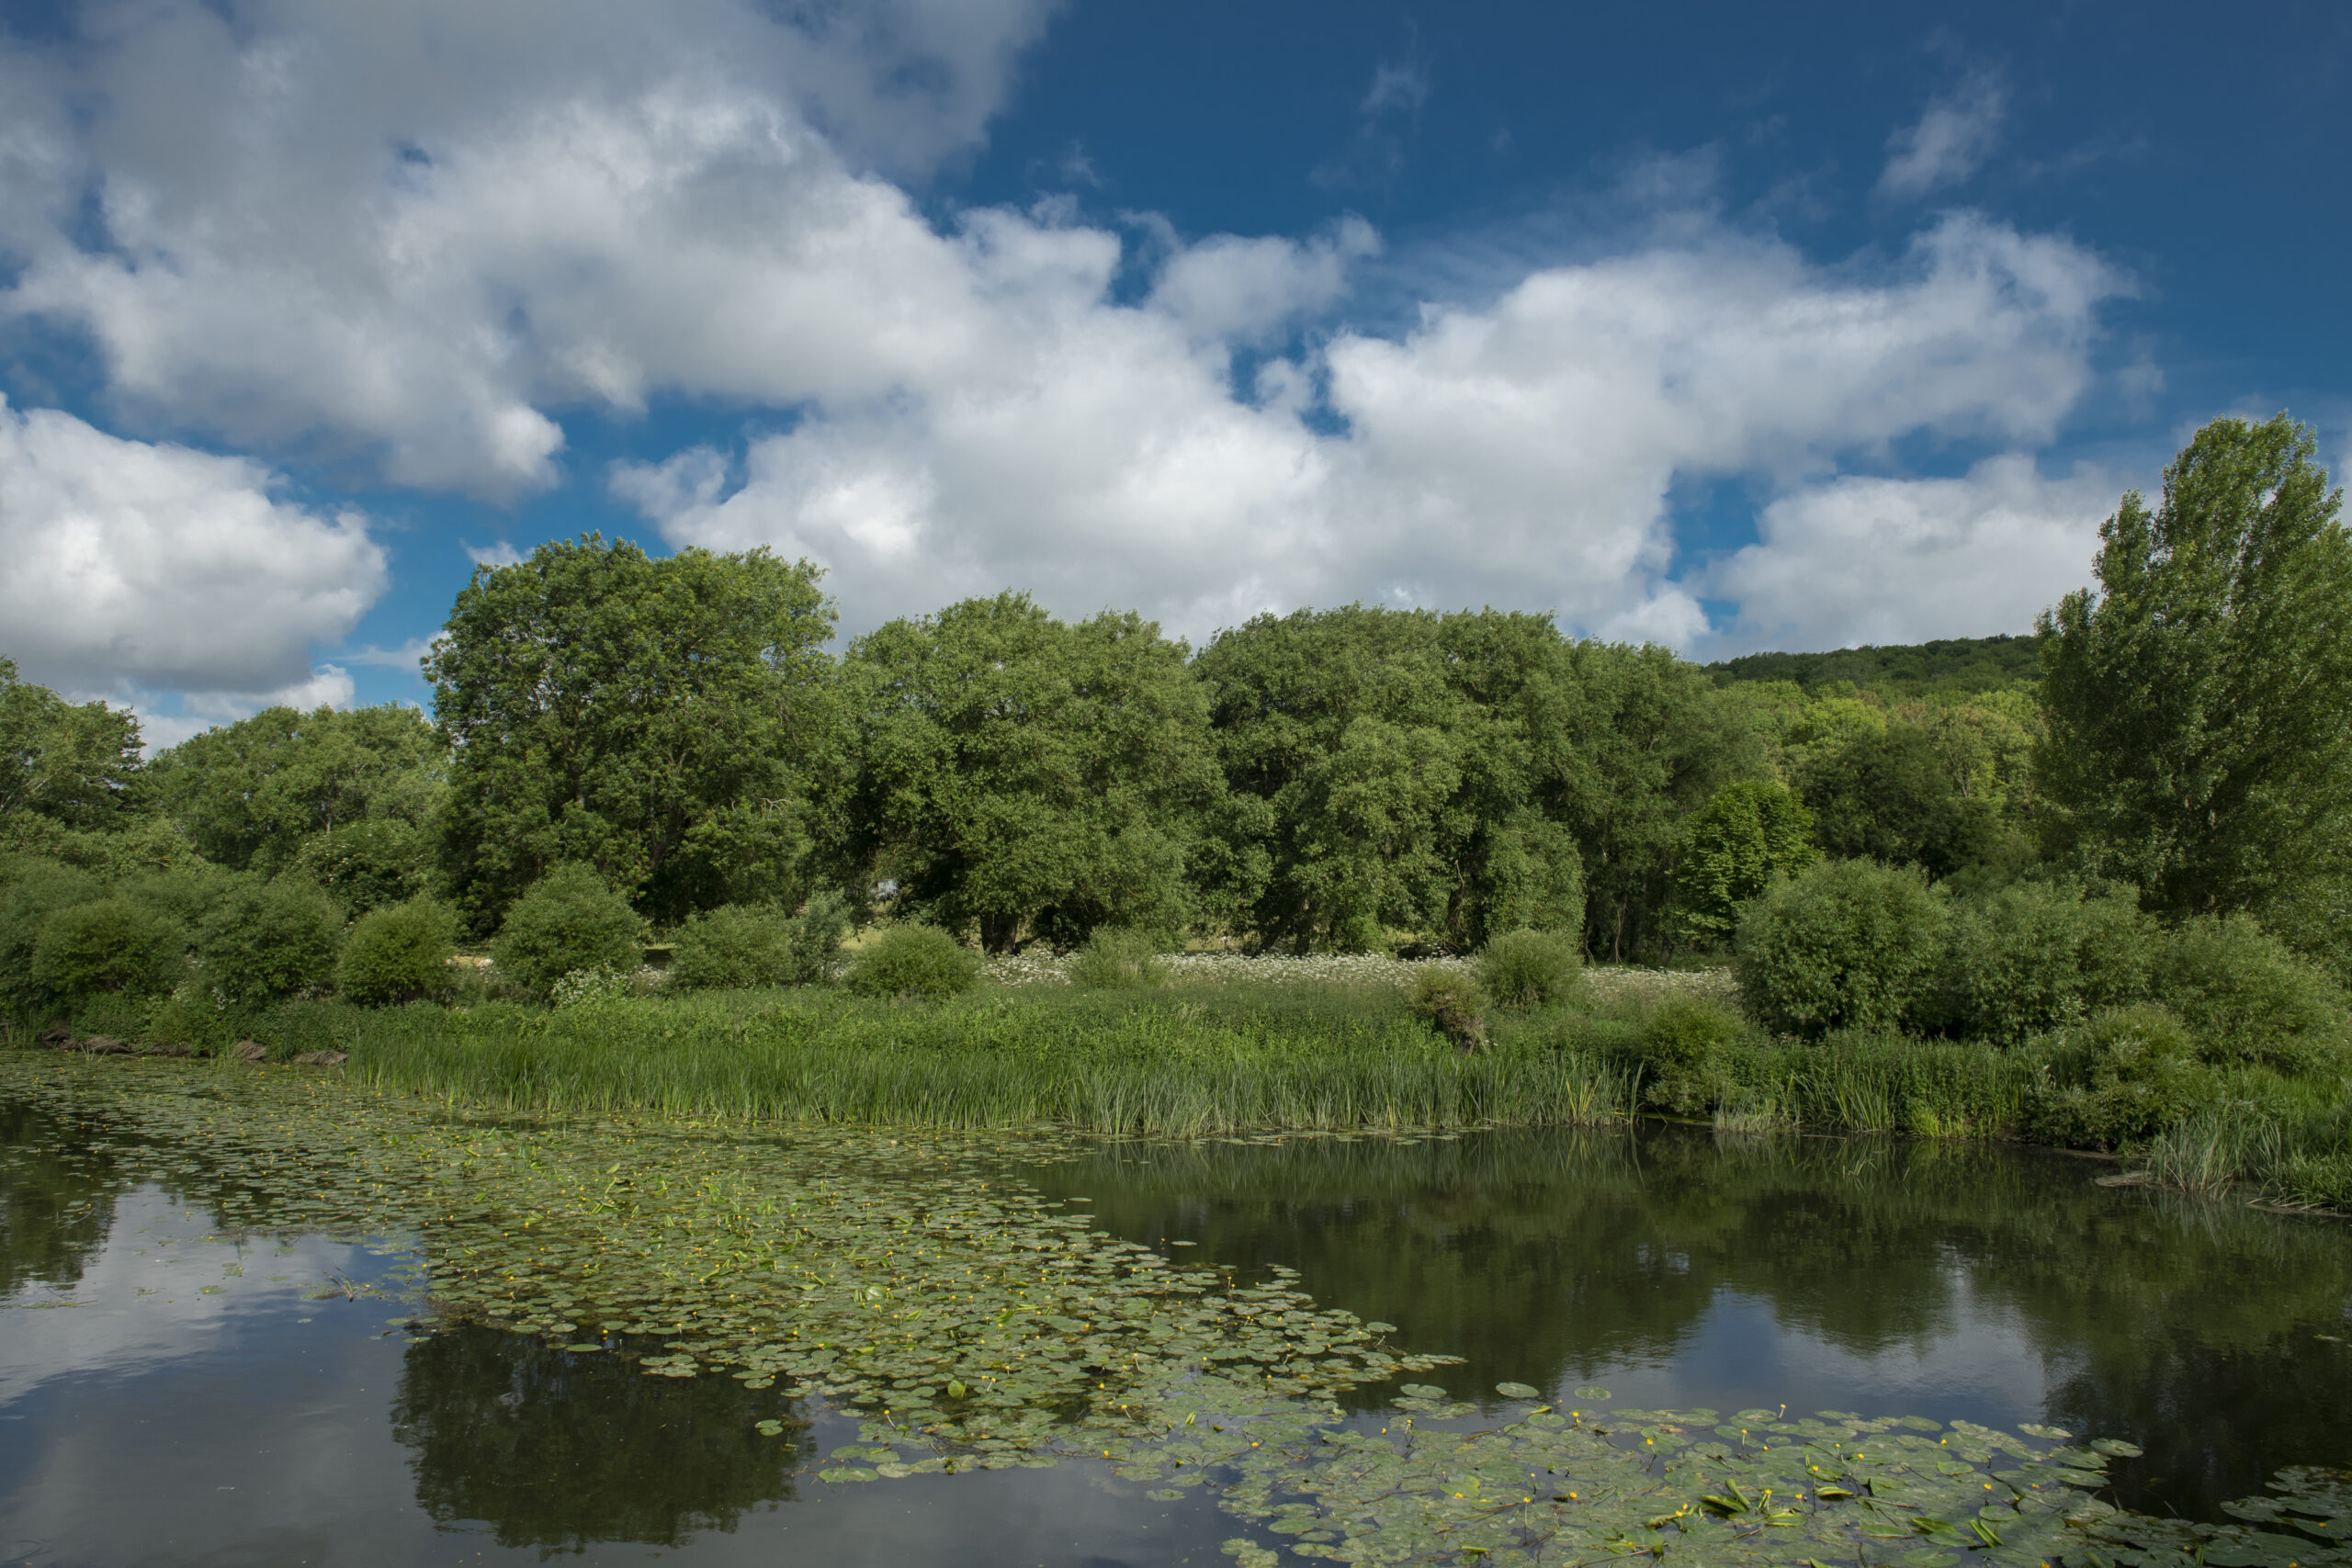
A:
[0,1054,2352,1568]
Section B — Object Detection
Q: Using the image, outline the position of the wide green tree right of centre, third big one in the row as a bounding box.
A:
[1194,604,1595,952]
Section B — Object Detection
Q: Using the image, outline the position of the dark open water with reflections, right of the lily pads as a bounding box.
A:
[1035,1128,2352,1518]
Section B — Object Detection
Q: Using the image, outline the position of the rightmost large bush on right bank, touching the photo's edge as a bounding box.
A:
[2150,915,2345,1072]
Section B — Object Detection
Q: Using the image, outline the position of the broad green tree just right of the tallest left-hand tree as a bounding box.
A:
[844,592,1218,952]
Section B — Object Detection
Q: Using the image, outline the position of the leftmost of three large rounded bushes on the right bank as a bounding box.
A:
[1736,861,1945,1039]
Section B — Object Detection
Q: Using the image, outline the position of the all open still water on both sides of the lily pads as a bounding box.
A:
[0,1102,2352,1565]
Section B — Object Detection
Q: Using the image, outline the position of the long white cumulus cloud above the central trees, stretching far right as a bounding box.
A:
[614,219,2117,647]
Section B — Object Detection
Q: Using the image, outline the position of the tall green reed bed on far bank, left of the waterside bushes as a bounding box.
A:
[350,987,1633,1135]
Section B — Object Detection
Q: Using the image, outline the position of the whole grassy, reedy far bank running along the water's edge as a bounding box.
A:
[12,959,2352,1208]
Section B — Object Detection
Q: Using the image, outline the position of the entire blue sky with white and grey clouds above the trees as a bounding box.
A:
[0,0,2352,740]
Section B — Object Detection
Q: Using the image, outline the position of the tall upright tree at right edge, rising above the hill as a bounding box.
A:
[2040,413,2352,945]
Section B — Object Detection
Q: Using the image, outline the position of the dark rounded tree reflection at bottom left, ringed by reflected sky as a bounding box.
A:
[393,1328,809,1551]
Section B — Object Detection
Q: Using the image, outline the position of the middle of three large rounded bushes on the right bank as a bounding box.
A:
[1943,882,2150,1046]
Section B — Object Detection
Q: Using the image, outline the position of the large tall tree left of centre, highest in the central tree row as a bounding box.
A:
[425,534,840,926]
